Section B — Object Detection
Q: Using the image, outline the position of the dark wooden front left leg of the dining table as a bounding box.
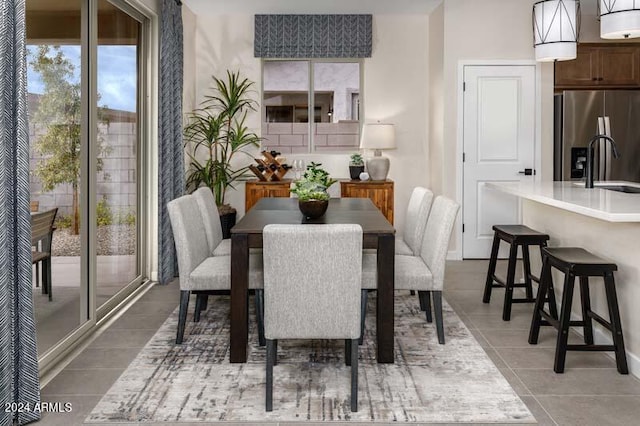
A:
[230,234,249,362]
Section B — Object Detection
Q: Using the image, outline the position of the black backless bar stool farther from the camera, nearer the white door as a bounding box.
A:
[482,225,555,321]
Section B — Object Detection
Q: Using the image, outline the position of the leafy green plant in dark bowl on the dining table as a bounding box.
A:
[290,162,337,219]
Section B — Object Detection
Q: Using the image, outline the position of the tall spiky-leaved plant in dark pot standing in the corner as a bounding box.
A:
[184,71,260,238]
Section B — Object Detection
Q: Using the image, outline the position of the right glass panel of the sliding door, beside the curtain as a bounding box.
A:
[95,0,142,307]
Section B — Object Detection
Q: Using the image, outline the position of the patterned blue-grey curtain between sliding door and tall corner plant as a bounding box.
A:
[158,0,185,284]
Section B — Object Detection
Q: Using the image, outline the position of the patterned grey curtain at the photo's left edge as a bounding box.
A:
[0,0,40,425]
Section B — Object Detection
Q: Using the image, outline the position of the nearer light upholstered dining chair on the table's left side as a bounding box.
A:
[167,195,264,344]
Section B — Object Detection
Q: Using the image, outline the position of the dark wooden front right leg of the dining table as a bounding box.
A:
[376,234,395,364]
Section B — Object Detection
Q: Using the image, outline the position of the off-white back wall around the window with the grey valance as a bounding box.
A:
[185,14,430,232]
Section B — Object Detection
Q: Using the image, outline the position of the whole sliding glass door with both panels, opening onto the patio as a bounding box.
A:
[26,0,150,366]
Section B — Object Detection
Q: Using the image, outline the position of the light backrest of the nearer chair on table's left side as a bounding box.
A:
[167,195,210,290]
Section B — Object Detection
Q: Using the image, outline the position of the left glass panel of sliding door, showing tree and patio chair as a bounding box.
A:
[26,0,89,355]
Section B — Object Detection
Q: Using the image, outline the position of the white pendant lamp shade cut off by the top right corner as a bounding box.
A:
[598,0,640,39]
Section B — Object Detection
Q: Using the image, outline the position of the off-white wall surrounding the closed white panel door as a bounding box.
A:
[438,0,553,256]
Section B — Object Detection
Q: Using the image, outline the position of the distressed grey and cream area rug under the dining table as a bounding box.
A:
[87,293,535,423]
